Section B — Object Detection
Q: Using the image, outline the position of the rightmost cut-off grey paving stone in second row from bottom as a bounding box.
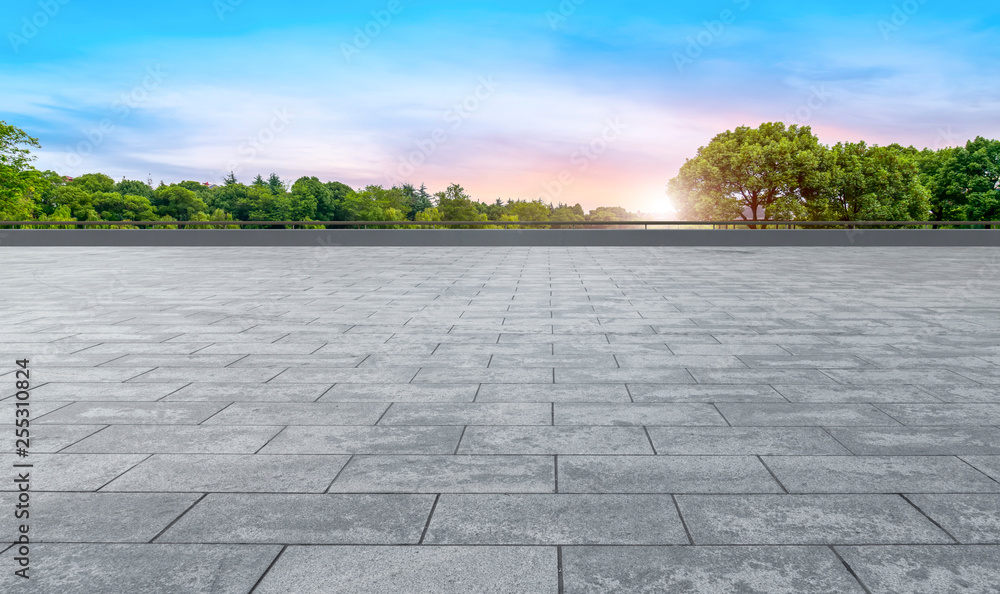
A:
[906,494,1000,544]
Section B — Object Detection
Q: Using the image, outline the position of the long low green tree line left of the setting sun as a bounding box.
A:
[0,122,639,228]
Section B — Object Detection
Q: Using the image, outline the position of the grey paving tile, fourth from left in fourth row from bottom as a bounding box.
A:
[458,427,653,455]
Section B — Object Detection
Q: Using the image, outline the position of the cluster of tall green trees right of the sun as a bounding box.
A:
[668,122,1000,221]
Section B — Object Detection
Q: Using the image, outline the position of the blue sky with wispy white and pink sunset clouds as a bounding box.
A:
[0,0,1000,213]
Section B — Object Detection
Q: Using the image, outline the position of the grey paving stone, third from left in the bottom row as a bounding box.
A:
[563,547,864,594]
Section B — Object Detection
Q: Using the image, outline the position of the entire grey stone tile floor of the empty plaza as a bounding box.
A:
[0,247,1000,594]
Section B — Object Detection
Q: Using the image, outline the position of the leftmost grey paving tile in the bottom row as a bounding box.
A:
[0,544,281,594]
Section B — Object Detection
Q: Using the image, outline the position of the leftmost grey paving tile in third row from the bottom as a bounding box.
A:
[0,454,146,491]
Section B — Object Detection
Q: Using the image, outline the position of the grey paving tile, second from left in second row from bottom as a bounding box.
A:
[157,493,434,544]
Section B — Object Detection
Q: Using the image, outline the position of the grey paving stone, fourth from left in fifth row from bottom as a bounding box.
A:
[379,402,552,425]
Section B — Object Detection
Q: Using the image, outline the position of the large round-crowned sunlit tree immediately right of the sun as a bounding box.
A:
[668,122,826,221]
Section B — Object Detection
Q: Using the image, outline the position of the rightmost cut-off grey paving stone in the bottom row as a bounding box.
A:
[836,546,1000,594]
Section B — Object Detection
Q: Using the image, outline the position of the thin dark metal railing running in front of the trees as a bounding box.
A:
[0,221,1000,229]
